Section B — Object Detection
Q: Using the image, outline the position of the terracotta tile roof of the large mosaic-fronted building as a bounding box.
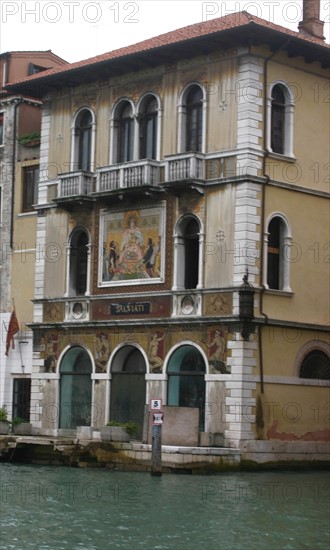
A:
[6,11,329,84]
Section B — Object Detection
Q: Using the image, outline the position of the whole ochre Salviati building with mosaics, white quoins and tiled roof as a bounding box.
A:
[9,3,329,458]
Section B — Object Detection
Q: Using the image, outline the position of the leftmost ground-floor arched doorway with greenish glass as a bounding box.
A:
[59,346,93,429]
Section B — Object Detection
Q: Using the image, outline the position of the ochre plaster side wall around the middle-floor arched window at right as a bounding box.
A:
[264,187,330,324]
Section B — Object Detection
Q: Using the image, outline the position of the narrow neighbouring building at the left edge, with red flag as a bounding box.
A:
[0,51,66,419]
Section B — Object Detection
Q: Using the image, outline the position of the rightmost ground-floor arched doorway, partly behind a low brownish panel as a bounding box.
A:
[167,345,205,432]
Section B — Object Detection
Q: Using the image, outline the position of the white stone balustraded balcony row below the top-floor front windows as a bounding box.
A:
[47,151,236,209]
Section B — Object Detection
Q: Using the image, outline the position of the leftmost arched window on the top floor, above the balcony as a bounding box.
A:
[74,109,93,172]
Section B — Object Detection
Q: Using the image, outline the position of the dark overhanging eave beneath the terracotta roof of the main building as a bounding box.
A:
[7,20,330,97]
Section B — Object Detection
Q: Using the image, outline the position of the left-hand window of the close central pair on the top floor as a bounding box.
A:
[117,101,134,162]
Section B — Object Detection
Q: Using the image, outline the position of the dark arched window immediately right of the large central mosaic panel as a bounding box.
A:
[174,216,202,290]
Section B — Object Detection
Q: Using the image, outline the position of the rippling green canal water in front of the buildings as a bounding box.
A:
[0,464,330,550]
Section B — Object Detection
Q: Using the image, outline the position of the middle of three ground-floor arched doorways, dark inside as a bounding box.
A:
[110,345,146,437]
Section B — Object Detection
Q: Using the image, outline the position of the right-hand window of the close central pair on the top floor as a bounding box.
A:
[139,95,158,159]
